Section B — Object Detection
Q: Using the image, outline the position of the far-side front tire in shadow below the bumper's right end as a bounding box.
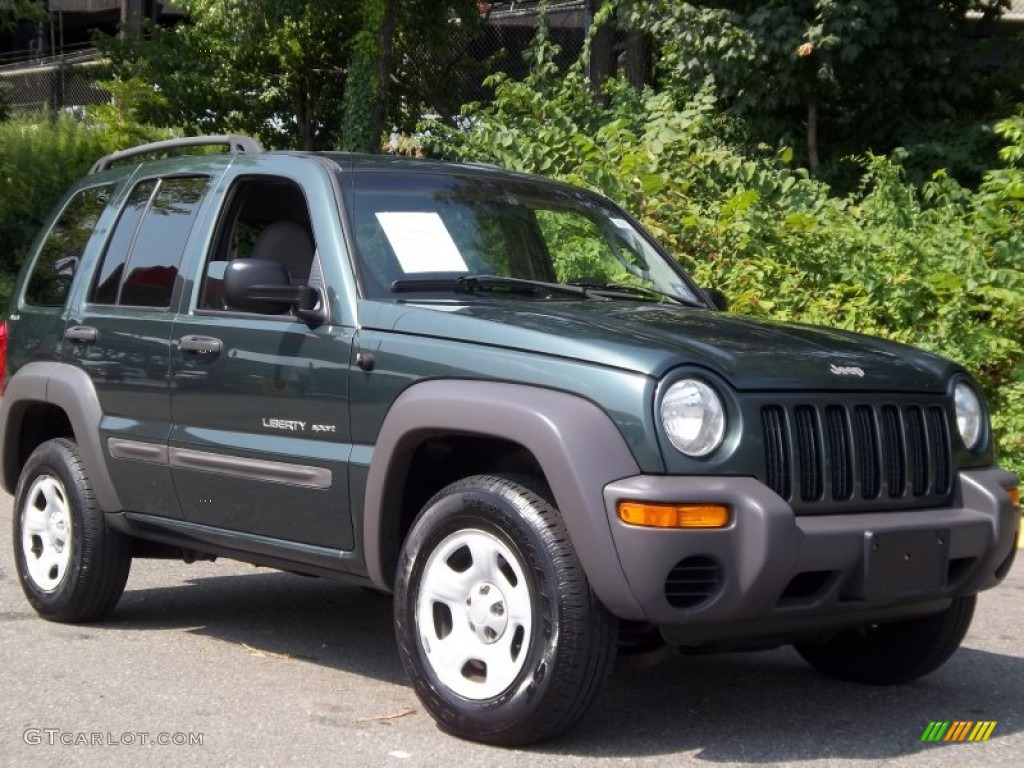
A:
[794,595,977,685]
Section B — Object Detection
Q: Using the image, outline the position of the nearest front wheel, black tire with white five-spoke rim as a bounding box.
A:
[394,475,616,746]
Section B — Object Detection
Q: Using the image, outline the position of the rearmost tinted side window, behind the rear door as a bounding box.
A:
[25,184,114,306]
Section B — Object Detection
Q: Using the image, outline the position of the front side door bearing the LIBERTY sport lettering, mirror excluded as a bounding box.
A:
[169,168,353,551]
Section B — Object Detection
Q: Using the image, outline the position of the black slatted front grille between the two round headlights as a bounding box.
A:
[761,402,952,512]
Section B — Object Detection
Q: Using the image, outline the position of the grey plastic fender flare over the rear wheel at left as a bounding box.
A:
[0,361,123,512]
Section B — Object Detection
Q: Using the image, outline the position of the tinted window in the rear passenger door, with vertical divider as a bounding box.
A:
[90,176,210,307]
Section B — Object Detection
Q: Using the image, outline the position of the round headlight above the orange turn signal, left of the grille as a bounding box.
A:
[662,379,725,457]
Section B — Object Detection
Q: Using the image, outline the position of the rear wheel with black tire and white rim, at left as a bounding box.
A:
[13,438,131,622]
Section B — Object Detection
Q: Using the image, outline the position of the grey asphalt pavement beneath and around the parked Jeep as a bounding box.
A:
[0,496,1024,768]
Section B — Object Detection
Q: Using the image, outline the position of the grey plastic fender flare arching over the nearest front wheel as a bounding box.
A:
[362,380,643,617]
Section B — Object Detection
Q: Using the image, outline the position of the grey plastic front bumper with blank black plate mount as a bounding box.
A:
[604,469,1020,644]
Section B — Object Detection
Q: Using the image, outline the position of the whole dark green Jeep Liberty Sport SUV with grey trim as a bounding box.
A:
[0,136,1020,744]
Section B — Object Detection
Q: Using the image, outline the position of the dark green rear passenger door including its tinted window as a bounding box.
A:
[63,175,211,517]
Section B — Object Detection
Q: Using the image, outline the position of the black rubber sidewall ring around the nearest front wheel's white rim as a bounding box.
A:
[395,487,561,736]
